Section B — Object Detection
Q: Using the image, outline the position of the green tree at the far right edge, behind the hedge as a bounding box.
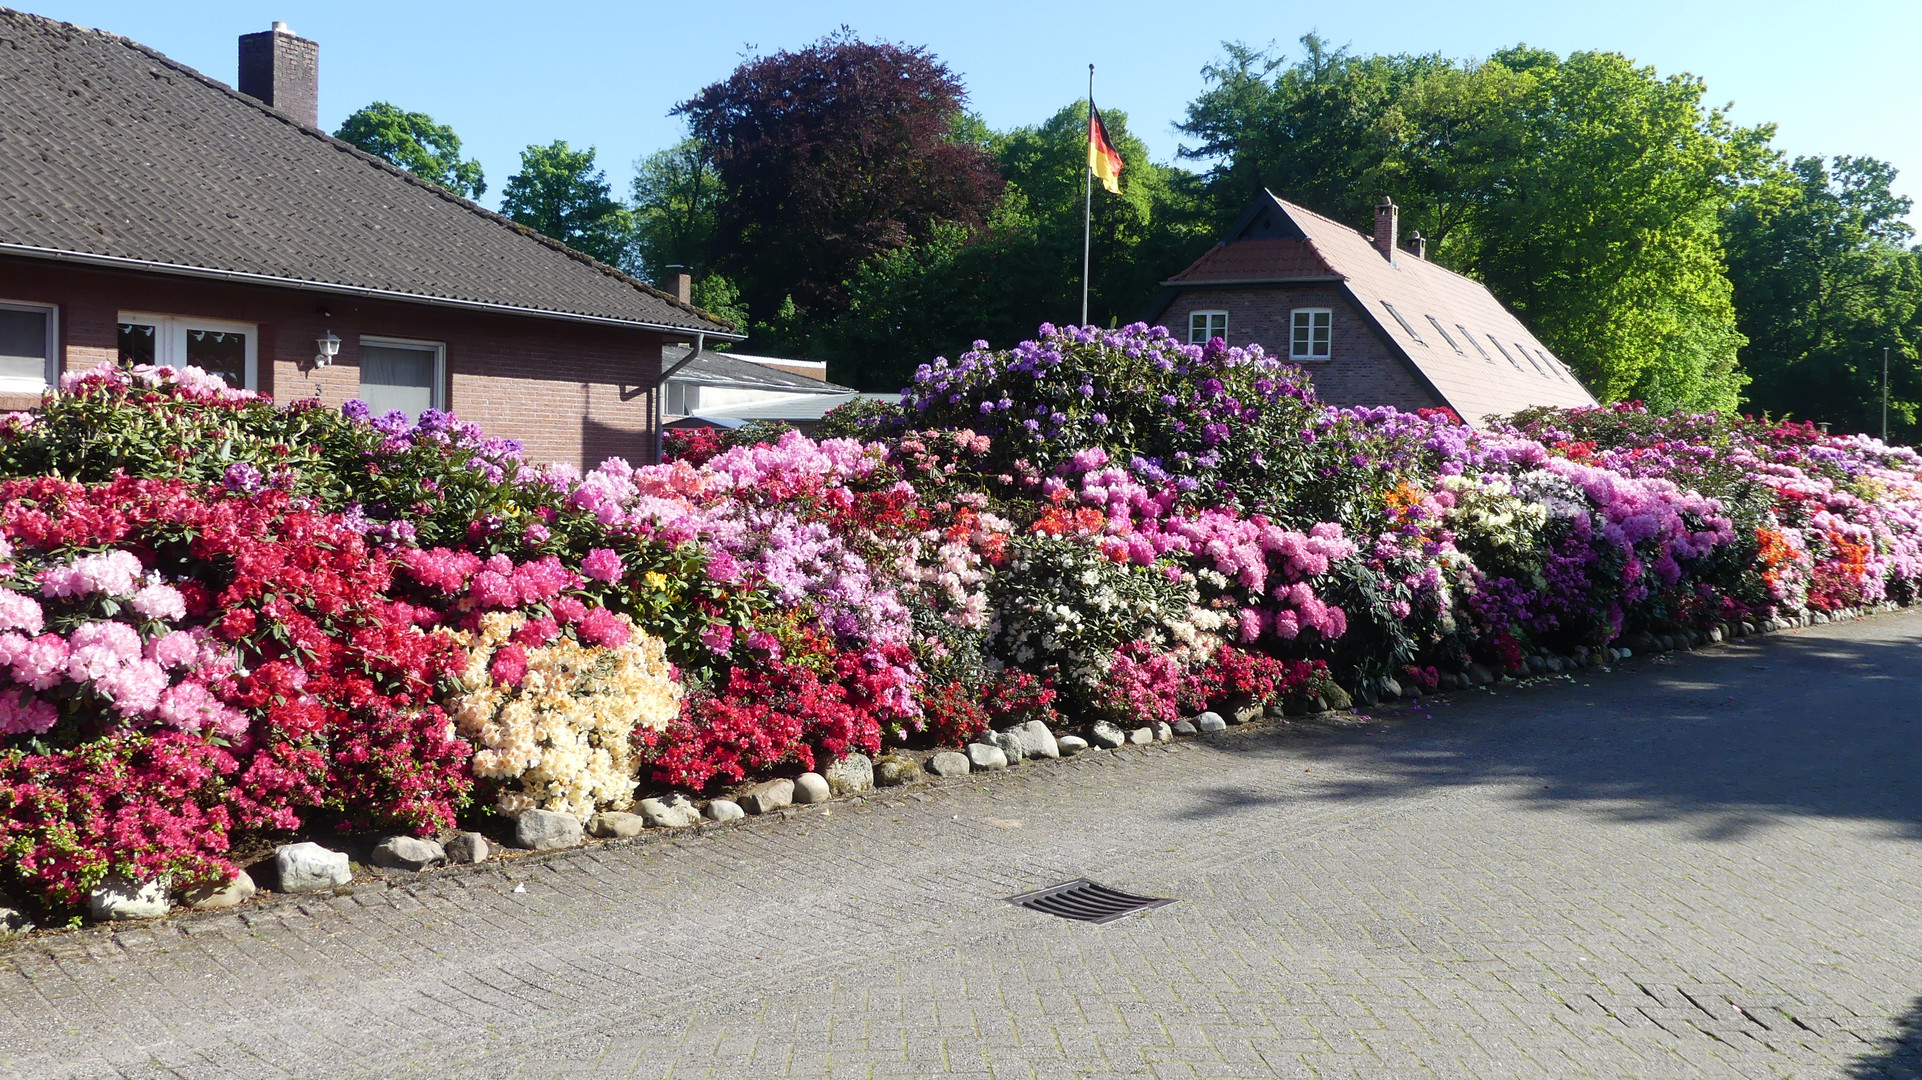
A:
[1726,158,1922,442]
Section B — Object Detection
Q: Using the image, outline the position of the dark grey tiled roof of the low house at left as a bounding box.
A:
[0,8,728,334]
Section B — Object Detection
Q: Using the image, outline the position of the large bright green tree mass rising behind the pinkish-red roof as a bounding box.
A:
[1182,37,1768,409]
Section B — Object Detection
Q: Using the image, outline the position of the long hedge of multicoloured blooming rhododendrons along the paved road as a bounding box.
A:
[0,327,1922,905]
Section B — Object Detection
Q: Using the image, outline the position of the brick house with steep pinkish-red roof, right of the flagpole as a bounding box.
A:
[1149,192,1595,425]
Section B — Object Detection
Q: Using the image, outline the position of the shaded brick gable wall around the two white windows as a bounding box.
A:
[1157,284,1442,411]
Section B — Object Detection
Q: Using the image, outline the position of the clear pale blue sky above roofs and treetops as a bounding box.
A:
[26,0,1922,223]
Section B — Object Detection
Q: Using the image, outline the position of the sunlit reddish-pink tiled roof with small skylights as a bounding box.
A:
[1268,194,1595,425]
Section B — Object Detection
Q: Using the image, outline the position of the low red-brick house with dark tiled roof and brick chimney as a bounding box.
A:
[0,10,740,467]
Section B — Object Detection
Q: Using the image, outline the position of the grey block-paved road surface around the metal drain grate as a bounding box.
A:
[0,615,1922,1080]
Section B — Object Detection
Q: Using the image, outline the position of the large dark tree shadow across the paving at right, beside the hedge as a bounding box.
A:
[1195,615,1922,840]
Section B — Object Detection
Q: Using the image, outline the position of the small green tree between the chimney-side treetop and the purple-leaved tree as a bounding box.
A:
[500,138,634,267]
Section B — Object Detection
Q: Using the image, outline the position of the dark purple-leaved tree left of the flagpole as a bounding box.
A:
[675,31,999,315]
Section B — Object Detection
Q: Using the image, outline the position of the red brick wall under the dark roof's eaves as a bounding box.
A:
[0,258,676,467]
